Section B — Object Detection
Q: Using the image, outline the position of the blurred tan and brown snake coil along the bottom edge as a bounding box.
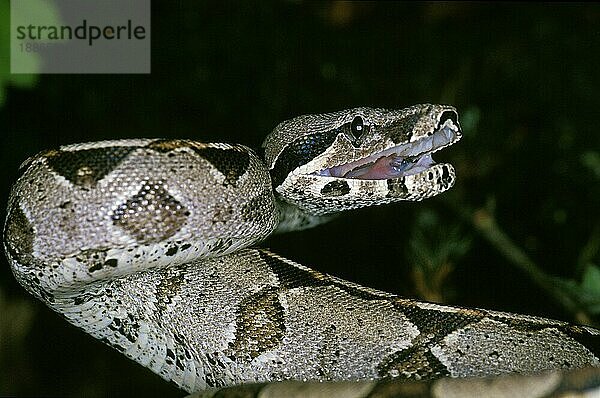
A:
[193,368,600,398]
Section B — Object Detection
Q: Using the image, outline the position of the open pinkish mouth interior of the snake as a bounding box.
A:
[315,118,460,180]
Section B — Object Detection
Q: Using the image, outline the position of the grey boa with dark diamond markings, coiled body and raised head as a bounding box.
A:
[4,105,600,392]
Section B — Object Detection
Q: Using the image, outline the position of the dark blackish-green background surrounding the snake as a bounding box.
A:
[0,0,600,397]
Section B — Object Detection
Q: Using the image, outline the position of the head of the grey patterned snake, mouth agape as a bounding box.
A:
[263,104,462,215]
